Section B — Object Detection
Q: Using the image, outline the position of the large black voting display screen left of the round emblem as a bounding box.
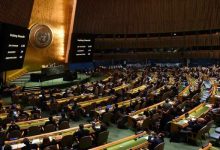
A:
[0,23,29,71]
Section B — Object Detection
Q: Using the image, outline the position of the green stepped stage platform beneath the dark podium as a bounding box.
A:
[10,71,90,89]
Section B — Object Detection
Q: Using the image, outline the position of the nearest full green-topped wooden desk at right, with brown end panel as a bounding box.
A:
[171,103,211,133]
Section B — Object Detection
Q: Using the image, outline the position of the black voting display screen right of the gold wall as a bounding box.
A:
[69,33,95,63]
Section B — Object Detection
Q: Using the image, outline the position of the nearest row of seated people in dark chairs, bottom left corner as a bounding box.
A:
[1,122,109,150]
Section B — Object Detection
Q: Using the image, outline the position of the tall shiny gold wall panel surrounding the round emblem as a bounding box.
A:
[24,0,75,71]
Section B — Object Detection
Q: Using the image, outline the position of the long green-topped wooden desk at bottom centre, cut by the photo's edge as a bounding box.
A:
[90,132,148,150]
